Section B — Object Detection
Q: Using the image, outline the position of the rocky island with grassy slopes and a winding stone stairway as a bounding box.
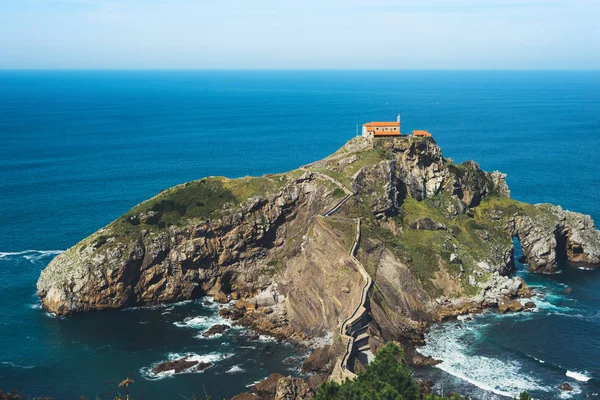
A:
[37,136,600,398]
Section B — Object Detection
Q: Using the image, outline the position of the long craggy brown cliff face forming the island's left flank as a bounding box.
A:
[38,173,344,314]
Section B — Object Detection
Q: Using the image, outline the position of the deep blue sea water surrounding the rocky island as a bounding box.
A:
[0,71,600,399]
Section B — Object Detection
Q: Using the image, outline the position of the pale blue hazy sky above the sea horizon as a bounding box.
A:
[0,0,600,69]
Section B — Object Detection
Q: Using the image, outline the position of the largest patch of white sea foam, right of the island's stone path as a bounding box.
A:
[417,324,552,397]
